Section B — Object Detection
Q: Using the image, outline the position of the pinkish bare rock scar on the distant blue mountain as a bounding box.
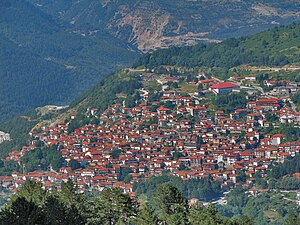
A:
[107,2,219,52]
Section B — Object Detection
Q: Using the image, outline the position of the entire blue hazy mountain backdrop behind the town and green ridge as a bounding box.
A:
[0,0,300,123]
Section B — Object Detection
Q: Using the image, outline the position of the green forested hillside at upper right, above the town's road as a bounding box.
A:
[134,24,300,69]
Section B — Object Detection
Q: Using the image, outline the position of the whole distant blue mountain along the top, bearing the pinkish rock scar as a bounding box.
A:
[30,0,300,52]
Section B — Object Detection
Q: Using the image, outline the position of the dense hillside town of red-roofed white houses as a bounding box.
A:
[0,71,300,203]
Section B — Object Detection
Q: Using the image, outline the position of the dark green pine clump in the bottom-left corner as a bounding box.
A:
[0,181,85,224]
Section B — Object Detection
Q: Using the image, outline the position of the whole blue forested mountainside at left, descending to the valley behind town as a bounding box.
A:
[0,0,136,123]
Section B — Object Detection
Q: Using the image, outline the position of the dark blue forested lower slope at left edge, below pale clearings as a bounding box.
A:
[0,32,74,121]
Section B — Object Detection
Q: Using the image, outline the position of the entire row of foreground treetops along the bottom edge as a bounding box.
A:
[0,181,255,225]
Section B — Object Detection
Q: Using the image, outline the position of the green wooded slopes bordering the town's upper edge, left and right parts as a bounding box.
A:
[0,22,300,155]
